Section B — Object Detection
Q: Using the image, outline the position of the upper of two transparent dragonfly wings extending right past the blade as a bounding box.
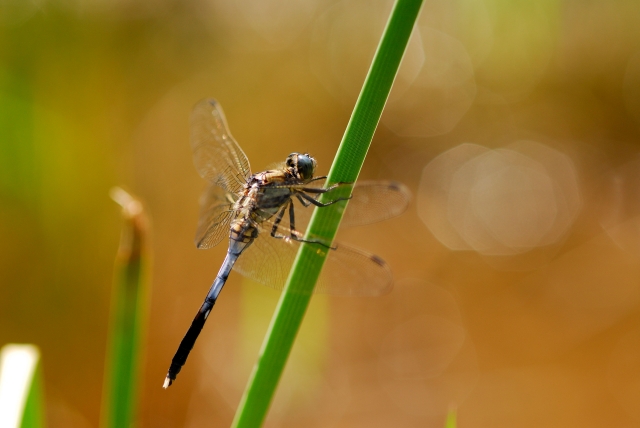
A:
[282,180,411,230]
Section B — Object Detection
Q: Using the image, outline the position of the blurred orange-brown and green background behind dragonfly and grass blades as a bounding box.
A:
[0,0,640,428]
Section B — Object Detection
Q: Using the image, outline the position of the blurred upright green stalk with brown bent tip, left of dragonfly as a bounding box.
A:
[101,188,149,428]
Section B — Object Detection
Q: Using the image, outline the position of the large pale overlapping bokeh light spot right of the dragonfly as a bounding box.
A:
[418,141,581,255]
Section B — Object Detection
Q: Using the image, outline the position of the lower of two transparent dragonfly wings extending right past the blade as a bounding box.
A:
[233,222,393,296]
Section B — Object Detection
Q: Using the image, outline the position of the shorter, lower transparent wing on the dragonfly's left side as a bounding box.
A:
[195,184,237,249]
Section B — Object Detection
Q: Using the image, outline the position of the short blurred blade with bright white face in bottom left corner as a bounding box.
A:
[0,344,45,428]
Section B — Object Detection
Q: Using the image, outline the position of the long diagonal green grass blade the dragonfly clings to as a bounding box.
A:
[232,0,422,428]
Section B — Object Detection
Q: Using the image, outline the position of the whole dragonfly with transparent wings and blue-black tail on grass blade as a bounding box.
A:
[163,99,411,389]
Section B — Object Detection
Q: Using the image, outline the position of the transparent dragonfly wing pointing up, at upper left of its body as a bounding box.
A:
[191,99,251,194]
